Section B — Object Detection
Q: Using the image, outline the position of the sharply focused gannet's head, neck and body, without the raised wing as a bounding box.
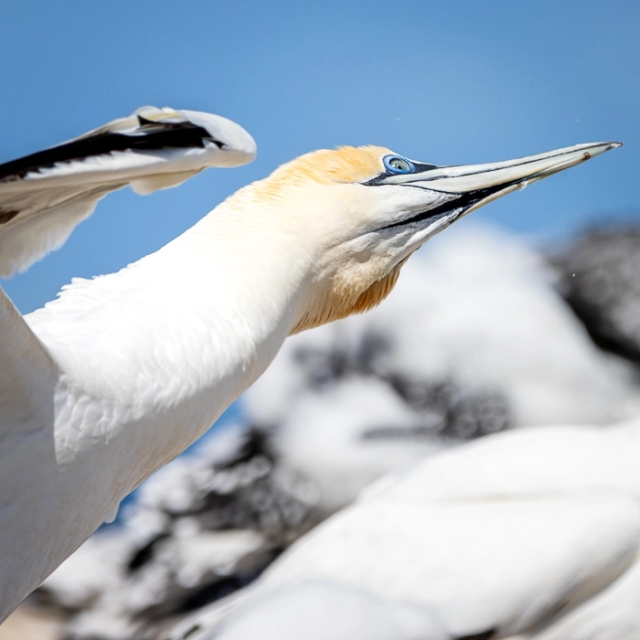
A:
[0,116,619,619]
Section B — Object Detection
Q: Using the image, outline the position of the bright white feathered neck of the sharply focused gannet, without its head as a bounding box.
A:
[28,185,314,509]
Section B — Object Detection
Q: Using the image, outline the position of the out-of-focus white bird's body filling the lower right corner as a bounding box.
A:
[171,419,640,640]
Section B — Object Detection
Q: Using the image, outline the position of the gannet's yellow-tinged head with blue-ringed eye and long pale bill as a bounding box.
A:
[249,142,620,333]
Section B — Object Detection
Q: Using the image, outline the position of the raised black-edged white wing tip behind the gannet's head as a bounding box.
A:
[0,107,256,276]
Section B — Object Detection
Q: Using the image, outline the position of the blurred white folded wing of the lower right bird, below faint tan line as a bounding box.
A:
[262,494,640,638]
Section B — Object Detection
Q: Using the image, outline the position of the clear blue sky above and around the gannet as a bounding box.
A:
[0,0,640,312]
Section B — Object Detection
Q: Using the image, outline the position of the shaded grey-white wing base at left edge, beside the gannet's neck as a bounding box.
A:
[0,289,69,619]
